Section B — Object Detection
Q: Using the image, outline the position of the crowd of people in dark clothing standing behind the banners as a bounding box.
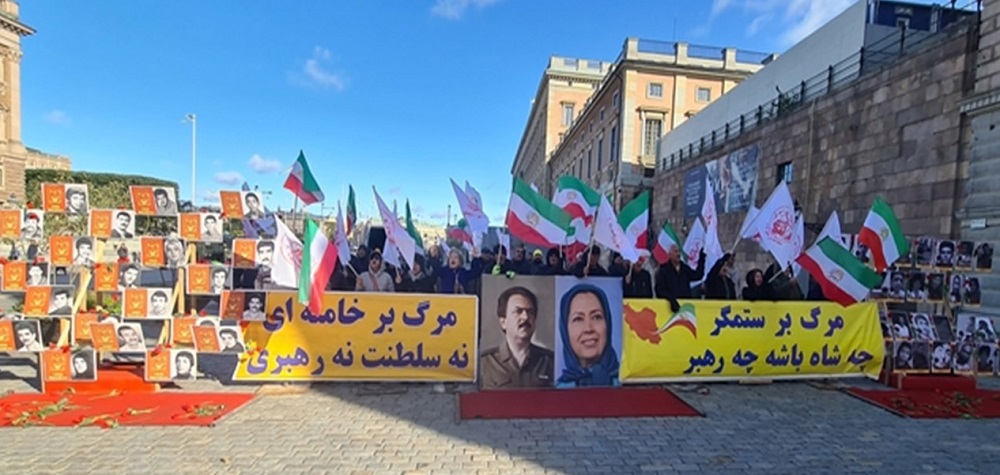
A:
[318,242,825,310]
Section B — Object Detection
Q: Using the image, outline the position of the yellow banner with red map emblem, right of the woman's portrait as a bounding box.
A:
[621,299,885,382]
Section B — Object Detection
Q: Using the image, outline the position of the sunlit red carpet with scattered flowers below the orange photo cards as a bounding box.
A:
[0,391,253,429]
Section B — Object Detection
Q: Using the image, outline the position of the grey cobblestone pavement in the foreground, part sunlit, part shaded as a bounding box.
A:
[0,356,1000,475]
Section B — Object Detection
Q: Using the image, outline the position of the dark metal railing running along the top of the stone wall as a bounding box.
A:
[656,1,979,171]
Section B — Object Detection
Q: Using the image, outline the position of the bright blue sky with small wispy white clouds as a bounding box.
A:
[20,0,852,224]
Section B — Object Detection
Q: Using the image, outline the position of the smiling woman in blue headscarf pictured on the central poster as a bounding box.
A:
[556,284,620,388]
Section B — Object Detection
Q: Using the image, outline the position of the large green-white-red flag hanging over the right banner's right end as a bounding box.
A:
[795,237,882,307]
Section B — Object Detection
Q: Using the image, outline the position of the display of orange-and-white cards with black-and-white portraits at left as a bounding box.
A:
[0,183,275,381]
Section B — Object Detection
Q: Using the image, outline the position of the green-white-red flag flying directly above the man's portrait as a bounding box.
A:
[507,177,571,247]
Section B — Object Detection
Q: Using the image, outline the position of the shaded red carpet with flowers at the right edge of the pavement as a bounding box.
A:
[847,388,1000,419]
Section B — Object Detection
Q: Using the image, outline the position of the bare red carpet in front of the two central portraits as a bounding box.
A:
[458,388,701,419]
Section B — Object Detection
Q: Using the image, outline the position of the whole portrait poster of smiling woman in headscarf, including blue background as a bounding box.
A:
[556,277,621,388]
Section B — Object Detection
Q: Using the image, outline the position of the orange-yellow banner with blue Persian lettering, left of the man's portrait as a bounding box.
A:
[233,292,479,382]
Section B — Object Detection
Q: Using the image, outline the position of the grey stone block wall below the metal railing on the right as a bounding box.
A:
[652,16,980,298]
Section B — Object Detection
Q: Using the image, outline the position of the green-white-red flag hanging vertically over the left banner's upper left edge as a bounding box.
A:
[299,218,337,315]
